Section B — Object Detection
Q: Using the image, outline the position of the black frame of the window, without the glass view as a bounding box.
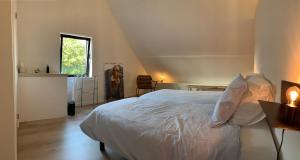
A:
[59,33,91,77]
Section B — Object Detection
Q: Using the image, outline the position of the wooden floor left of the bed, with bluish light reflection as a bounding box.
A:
[18,107,122,160]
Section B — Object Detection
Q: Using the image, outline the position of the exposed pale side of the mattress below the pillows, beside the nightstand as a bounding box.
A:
[240,119,277,160]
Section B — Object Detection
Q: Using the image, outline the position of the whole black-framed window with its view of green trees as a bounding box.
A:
[60,34,91,76]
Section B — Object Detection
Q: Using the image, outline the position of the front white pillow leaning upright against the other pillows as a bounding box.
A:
[211,74,247,127]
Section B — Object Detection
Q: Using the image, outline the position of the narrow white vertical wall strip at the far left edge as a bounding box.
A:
[0,0,17,160]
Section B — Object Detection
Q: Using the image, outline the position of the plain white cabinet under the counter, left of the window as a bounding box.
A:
[17,74,68,122]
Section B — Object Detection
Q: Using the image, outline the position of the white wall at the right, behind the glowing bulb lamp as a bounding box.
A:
[255,0,300,160]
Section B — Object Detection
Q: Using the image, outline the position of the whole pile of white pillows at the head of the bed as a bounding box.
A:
[211,74,275,127]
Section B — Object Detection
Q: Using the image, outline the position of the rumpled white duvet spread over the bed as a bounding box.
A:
[81,90,240,160]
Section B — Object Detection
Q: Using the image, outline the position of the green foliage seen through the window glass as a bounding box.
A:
[61,37,87,75]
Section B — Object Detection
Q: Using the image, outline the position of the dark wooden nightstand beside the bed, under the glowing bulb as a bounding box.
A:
[259,101,300,160]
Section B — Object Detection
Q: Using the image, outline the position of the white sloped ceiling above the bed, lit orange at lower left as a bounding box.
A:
[108,0,257,84]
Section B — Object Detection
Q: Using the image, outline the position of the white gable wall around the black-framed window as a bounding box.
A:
[18,0,145,101]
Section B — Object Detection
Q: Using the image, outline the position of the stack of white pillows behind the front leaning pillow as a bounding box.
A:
[229,74,275,126]
